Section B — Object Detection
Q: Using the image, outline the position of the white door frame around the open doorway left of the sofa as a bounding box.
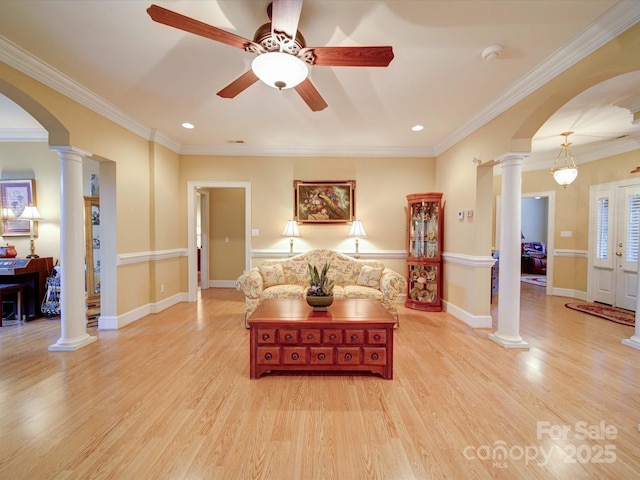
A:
[187,180,251,302]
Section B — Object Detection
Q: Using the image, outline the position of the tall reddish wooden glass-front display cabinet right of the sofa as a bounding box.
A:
[405,193,444,312]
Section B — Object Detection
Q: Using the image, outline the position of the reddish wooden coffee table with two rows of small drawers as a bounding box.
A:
[248,299,396,379]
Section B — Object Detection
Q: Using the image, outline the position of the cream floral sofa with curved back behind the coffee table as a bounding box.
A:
[236,250,407,326]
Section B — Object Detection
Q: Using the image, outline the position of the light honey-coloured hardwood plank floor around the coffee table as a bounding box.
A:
[0,284,640,480]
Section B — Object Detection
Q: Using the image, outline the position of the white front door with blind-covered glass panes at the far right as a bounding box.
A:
[590,185,640,311]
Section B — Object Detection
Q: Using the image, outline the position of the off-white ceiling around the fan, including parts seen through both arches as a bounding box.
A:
[0,0,640,167]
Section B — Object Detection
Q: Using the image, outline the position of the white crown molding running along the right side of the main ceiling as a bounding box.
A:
[434,0,640,155]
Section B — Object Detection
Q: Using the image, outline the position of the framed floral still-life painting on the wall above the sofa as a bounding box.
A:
[293,180,356,223]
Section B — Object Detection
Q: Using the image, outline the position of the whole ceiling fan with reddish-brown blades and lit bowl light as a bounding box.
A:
[147,0,393,112]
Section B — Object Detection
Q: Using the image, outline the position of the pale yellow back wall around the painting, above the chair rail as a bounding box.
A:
[180,156,435,280]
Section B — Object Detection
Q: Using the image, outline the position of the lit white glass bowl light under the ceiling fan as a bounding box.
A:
[251,52,309,90]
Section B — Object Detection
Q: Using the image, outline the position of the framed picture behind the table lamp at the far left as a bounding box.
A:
[0,180,38,237]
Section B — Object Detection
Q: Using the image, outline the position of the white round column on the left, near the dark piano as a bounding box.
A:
[49,147,97,352]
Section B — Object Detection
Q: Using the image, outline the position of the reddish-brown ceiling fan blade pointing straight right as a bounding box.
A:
[300,47,393,67]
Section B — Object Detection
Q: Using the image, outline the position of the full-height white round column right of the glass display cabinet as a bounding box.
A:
[489,155,529,348]
